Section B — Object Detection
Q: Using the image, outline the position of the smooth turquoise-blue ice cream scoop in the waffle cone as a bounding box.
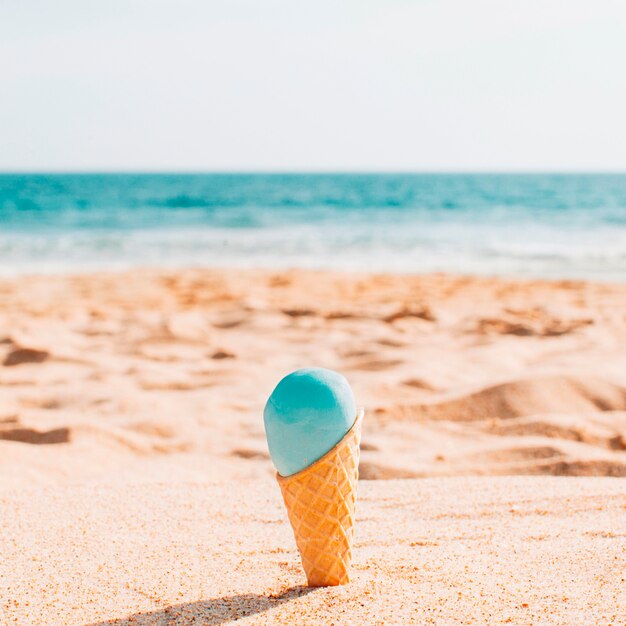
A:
[263,367,356,476]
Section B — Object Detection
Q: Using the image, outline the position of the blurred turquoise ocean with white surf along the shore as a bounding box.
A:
[0,174,626,281]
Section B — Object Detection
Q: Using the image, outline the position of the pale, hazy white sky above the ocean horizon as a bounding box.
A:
[0,0,626,171]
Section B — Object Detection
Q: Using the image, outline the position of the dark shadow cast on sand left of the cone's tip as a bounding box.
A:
[87,585,317,626]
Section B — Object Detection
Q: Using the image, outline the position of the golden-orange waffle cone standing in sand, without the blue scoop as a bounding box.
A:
[276,410,363,587]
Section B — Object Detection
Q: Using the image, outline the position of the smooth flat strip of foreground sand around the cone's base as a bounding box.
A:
[0,477,626,626]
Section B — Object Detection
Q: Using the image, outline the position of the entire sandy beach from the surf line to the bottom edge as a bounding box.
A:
[0,270,626,625]
